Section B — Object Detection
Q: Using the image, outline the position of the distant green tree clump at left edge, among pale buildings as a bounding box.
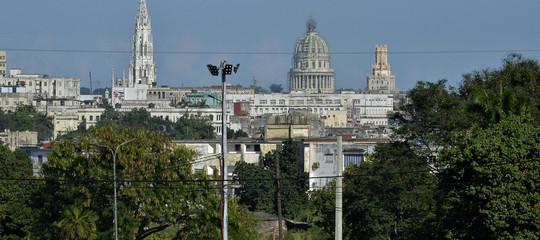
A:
[0,105,54,139]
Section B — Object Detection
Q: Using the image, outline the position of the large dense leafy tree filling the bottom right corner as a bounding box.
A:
[440,115,540,239]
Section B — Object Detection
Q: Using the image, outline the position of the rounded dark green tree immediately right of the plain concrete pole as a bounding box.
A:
[343,142,437,239]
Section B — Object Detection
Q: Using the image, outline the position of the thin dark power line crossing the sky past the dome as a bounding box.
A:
[2,48,540,55]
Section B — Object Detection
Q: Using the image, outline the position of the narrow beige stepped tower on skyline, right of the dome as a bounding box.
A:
[367,45,399,93]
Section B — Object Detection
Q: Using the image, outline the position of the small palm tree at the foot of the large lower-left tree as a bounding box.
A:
[55,205,98,240]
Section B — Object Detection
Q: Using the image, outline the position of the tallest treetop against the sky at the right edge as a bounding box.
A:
[459,54,540,126]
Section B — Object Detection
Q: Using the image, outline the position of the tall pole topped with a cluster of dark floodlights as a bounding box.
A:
[206,61,240,240]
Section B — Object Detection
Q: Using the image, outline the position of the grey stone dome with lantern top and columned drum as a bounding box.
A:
[289,17,334,93]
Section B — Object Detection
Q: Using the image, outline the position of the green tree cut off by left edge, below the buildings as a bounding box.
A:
[0,144,34,239]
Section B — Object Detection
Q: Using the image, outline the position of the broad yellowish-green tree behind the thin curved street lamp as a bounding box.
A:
[33,127,202,239]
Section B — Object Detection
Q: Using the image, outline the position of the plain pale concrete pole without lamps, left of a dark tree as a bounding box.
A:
[335,136,343,240]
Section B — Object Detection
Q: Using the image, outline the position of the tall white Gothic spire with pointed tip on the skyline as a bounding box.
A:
[127,0,156,87]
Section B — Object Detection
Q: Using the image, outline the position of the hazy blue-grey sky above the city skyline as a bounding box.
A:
[0,0,540,91]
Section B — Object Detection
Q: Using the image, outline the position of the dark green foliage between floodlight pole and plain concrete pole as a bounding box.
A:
[234,139,308,218]
